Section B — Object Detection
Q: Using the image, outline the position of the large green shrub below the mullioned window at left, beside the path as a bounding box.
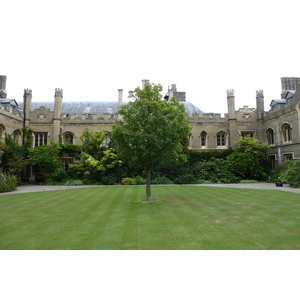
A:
[28,142,62,183]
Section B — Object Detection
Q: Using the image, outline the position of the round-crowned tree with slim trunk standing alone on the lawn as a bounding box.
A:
[111,83,190,200]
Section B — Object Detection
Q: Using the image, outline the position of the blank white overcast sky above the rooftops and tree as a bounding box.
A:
[0,0,300,113]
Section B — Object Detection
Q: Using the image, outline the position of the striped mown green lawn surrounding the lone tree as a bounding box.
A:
[0,185,300,249]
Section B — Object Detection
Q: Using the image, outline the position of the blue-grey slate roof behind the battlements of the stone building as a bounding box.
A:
[19,101,203,117]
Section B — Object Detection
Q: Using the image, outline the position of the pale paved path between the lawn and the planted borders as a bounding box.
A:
[0,182,300,195]
